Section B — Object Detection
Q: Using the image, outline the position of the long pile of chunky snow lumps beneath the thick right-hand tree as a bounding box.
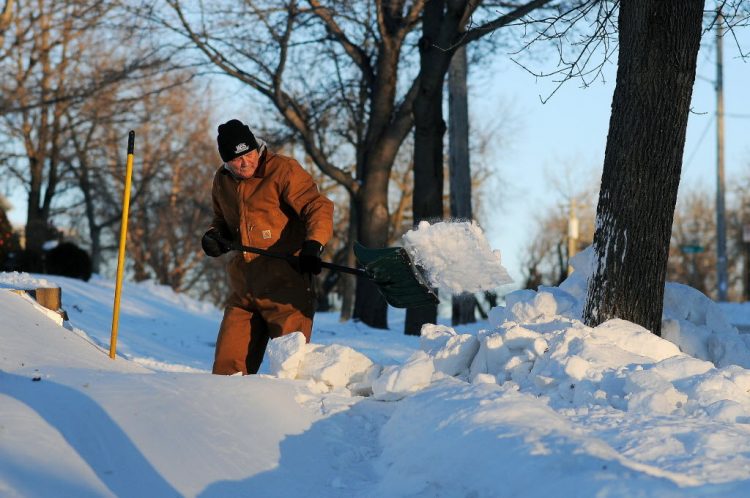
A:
[414,314,750,422]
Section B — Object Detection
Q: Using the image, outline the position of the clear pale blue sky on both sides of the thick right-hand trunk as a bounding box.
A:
[2,13,750,298]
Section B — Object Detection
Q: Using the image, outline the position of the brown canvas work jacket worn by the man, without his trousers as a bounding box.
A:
[211,149,333,305]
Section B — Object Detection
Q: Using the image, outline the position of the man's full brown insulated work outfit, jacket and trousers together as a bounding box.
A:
[211,150,333,375]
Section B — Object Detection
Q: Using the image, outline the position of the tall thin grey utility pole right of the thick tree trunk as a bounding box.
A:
[716,10,727,301]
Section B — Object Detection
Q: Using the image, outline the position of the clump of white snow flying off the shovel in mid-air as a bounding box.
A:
[403,221,513,294]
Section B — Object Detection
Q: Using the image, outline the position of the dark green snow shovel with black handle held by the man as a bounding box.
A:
[221,240,440,308]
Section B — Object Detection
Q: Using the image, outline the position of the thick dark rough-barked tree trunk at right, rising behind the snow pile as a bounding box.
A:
[584,0,703,335]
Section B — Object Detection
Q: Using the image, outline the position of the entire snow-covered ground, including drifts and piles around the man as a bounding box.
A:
[0,246,750,497]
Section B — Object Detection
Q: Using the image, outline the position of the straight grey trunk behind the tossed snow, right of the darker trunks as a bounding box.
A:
[448,46,476,325]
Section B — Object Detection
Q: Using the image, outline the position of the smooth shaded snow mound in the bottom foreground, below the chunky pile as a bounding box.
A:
[373,382,704,497]
